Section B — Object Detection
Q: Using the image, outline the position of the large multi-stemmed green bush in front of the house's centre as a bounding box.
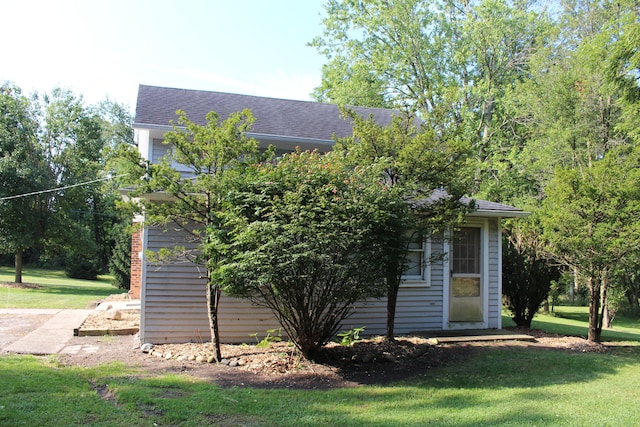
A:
[213,152,405,358]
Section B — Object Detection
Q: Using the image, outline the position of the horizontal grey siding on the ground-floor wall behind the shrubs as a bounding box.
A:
[140,224,500,344]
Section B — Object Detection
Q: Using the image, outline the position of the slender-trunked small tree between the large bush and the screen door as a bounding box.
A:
[335,111,473,341]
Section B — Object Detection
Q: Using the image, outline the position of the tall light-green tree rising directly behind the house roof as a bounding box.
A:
[311,0,550,194]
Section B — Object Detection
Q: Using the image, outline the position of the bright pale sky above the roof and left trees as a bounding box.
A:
[0,0,326,112]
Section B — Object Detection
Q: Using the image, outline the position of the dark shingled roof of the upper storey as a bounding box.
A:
[134,85,400,140]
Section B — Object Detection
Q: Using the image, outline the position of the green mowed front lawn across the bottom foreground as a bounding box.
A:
[0,307,640,426]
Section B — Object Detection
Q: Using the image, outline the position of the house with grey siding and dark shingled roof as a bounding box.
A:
[131,85,526,344]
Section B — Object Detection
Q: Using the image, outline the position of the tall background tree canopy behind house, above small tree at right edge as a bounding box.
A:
[310,0,640,338]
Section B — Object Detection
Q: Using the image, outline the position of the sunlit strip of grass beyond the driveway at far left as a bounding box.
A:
[0,267,119,308]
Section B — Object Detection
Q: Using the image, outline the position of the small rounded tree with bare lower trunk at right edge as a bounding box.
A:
[541,146,640,342]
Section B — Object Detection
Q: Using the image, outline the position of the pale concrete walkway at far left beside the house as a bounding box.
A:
[0,309,92,355]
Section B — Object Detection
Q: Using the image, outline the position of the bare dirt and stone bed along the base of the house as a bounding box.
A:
[53,324,607,389]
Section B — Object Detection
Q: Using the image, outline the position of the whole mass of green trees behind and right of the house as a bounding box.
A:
[310,0,640,341]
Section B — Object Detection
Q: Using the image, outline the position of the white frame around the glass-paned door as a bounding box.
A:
[442,218,489,331]
